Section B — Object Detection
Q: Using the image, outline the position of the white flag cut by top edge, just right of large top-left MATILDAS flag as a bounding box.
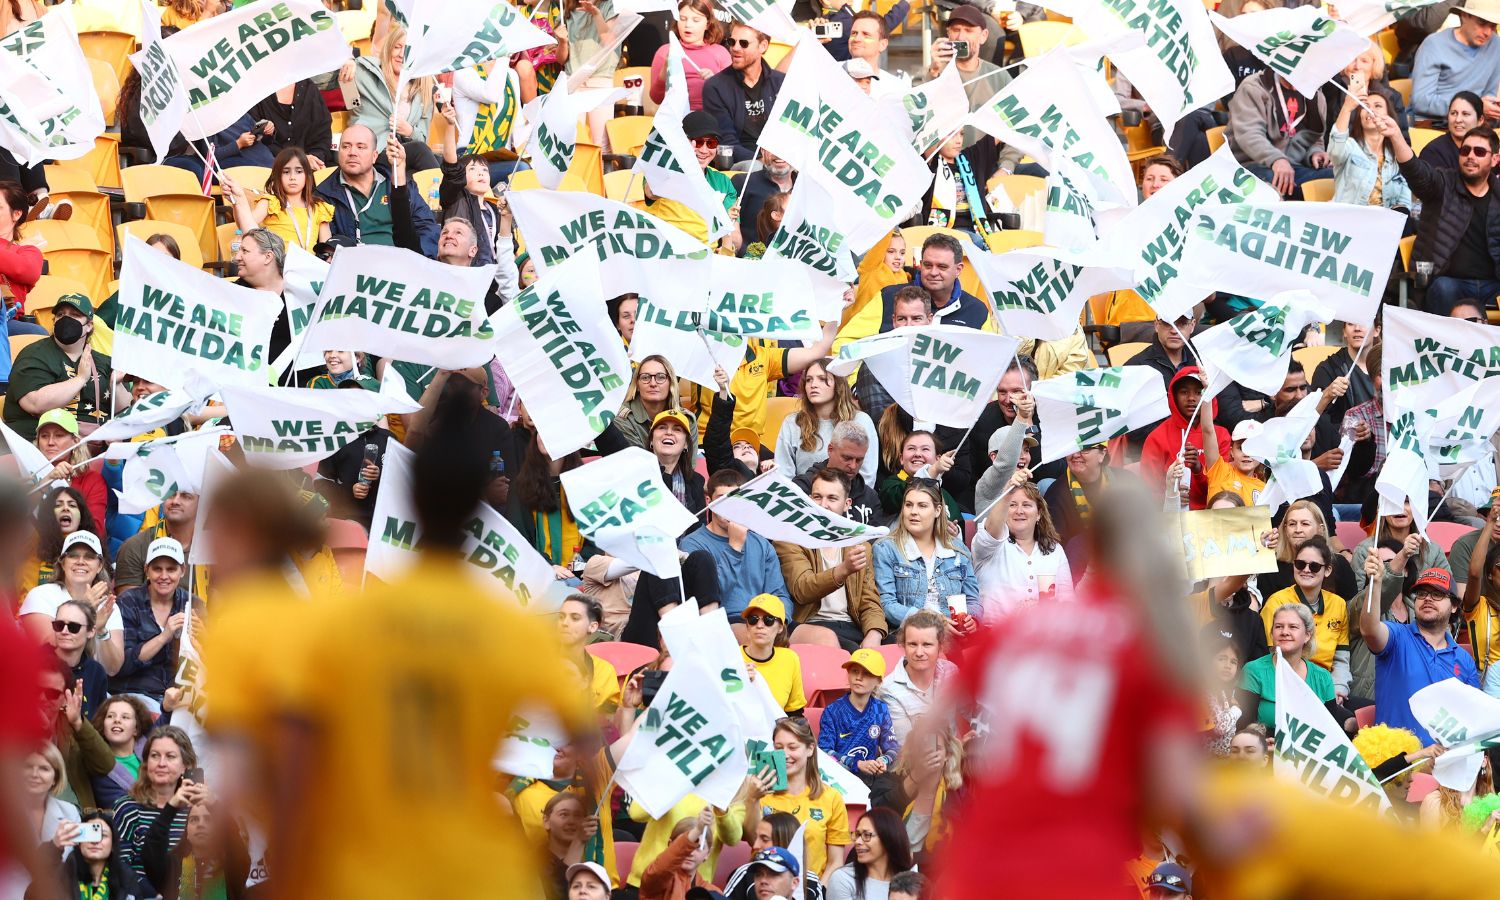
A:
[401,0,557,80]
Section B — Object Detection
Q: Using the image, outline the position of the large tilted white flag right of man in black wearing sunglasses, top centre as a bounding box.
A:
[761,32,930,254]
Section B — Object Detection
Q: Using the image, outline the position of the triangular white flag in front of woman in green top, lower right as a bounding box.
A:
[1275,650,1391,813]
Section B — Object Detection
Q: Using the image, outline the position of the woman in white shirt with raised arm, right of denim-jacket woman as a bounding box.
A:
[972,471,1074,621]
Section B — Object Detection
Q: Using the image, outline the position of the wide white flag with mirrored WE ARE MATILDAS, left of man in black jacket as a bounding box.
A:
[1182,203,1406,326]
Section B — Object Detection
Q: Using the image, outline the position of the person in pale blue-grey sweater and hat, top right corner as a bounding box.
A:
[1412,0,1500,119]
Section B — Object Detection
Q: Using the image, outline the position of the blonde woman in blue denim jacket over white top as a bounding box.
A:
[875,482,983,635]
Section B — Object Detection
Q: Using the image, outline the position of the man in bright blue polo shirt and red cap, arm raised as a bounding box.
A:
[1359,554,1479,747]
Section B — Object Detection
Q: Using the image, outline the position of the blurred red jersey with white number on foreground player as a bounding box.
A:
[938,594,1196,900]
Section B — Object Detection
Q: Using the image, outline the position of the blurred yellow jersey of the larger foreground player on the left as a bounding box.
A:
[273,552,588,900]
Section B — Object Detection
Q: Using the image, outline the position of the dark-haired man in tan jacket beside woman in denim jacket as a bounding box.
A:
[774,468,887,651]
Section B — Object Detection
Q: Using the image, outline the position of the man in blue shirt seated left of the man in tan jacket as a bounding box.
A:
[678,470,792,627]
